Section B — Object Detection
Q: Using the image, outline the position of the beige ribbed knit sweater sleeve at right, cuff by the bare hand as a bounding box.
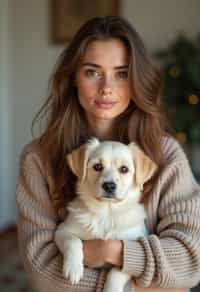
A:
[122,142,200,288]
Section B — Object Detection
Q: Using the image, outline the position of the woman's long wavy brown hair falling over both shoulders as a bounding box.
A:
[32,16,170,211]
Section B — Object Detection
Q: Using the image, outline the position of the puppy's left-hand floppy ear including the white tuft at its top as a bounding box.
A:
[67,138,100,181]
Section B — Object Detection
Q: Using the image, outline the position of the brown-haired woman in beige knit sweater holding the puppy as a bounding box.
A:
[17,16,200,292]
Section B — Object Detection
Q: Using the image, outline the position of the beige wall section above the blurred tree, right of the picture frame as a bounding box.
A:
[122,0,200,51]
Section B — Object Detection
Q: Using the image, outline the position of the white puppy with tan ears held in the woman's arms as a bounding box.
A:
[55,139,156,292]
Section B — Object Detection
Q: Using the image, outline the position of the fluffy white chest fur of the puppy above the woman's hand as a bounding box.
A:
[67,199,147,240]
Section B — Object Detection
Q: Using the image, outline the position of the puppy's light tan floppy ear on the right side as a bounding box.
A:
[128,143,157,189]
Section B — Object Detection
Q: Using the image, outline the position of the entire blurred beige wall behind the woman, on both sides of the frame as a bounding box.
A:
[0,0,200,228]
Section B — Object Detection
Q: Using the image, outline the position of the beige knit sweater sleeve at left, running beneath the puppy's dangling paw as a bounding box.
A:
[16,147,105,292]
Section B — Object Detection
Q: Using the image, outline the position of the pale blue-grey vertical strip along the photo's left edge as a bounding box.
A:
[0,0,15,228]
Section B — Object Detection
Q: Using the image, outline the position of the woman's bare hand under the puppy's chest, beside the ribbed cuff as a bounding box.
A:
[83,239,123,268]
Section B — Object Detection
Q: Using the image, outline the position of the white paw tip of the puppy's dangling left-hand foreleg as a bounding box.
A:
[63,260,84,284]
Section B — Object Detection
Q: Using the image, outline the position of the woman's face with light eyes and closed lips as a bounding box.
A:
[75,38,131,121]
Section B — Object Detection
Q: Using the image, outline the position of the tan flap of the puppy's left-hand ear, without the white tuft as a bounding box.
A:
[67,145,88,180]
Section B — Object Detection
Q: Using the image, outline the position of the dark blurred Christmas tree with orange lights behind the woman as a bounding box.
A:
[155,34,200,144]
